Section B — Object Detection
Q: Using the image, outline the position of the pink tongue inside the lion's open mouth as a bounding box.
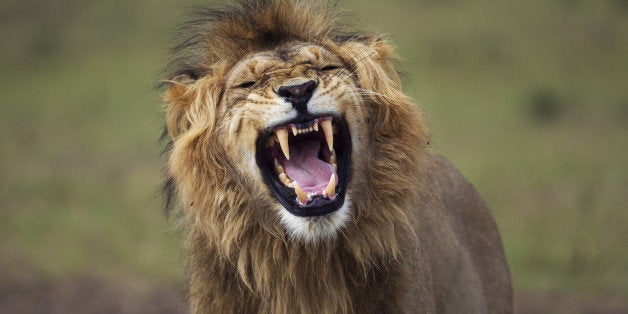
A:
[283,139,334,192]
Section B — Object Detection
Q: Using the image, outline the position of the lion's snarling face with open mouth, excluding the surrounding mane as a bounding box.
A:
[223,44,364,242]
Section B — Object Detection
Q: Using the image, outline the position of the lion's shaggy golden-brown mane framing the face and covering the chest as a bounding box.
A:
[164,0,510,313]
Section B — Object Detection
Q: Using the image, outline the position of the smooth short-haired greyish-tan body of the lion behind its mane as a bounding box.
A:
[418,153,512,313]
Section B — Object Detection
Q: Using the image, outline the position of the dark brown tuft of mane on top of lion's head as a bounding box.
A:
[164,0,357,80]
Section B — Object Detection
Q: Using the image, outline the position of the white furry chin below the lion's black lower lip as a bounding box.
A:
[278,196,351,244]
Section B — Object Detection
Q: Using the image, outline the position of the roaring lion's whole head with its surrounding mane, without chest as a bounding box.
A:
[165,0,427,242]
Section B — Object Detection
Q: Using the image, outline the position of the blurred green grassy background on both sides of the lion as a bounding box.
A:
[0,0,628,309]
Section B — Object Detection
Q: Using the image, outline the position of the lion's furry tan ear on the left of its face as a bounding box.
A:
[163,75,220,139]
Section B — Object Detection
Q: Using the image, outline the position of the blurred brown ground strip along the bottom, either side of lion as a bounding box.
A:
[0,277,628,314]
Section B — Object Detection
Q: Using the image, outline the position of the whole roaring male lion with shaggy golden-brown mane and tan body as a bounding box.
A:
[164,0,512,313]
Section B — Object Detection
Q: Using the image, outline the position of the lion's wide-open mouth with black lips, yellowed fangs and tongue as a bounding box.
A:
[257,116,351,217]
